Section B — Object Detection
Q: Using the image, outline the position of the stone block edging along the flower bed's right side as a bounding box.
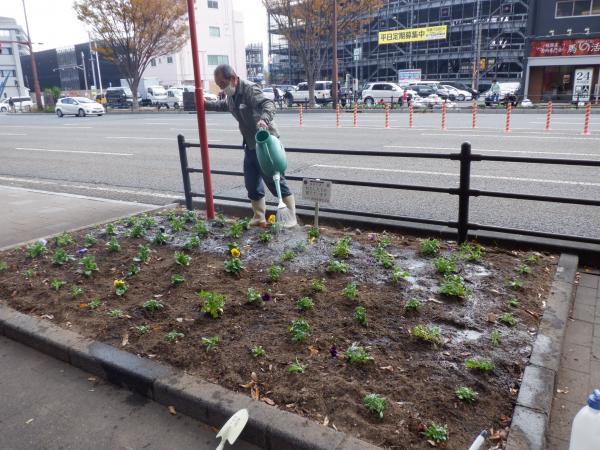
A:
[506,253,578,450]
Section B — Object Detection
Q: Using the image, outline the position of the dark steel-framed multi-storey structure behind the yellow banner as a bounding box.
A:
[269,0,529,89]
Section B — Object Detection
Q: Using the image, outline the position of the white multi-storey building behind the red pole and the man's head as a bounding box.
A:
[144,0,247,94]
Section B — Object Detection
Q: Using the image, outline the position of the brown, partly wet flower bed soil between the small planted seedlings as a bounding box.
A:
[0,211,556,450]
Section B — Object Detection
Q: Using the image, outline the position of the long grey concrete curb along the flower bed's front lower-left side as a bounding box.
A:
[0,303,379,450]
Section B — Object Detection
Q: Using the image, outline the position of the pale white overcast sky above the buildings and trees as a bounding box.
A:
[0,0,267,51]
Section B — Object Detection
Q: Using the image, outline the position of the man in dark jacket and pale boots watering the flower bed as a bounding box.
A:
[206,64,297,228]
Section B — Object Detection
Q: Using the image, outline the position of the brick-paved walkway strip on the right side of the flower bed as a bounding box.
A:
[548,272,600,450]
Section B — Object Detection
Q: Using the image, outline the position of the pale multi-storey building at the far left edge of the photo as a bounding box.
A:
[0,17,29,99]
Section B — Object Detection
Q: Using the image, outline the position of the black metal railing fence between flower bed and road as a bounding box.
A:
[177,135,600,244]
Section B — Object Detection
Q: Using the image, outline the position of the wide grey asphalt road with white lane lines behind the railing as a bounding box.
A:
[0,111,600,241]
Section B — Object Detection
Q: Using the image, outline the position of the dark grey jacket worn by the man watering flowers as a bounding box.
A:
[205,78,279,149]
